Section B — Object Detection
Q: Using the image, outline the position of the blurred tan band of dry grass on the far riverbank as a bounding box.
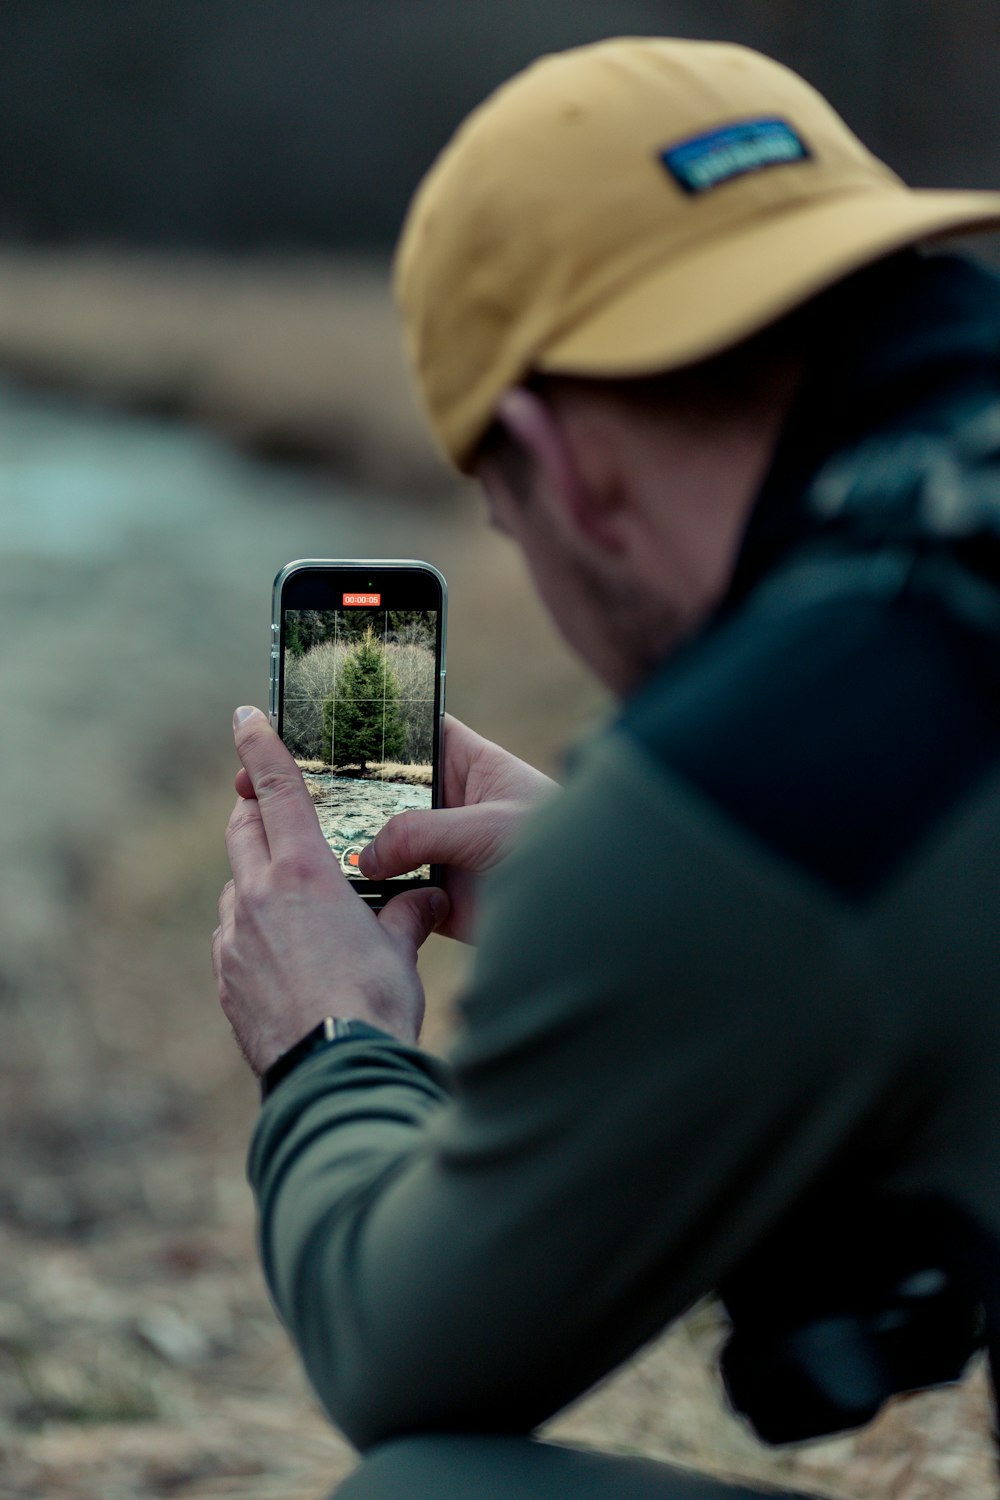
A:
[0,249,450,494]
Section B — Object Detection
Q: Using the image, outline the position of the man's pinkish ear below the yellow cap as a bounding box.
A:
[495,386,618,551]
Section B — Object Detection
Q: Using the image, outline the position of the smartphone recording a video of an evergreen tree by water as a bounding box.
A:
[270,558,448,908]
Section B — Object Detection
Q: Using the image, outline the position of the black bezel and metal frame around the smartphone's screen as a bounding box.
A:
[268,558,448,911]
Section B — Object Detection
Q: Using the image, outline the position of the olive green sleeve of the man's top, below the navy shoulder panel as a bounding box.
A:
[250,708,1000,1448]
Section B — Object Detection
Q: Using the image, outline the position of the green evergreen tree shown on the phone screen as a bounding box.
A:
[322,627,406,774]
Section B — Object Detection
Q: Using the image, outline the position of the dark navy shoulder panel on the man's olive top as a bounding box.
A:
[622,597,1000,897]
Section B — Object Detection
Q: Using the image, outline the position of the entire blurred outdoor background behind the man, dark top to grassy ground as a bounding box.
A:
[0,0,1000,1500]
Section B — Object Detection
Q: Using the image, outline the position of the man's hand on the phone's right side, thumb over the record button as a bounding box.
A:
[353,714,556,942]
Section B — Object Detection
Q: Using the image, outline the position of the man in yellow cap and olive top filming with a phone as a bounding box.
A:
[214,39,1000,1500]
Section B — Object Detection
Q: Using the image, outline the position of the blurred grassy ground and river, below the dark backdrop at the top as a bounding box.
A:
[0,255,993,1500]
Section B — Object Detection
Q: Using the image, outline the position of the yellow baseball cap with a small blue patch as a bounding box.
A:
[396,38,1000,468]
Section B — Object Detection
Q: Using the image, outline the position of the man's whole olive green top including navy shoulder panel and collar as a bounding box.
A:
[249,255,1000,1448]
